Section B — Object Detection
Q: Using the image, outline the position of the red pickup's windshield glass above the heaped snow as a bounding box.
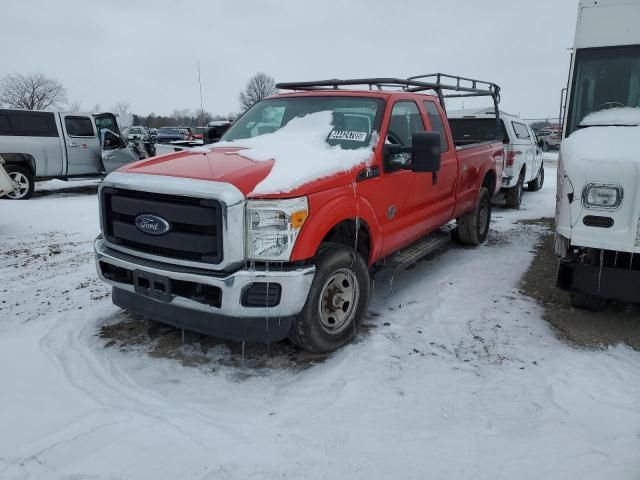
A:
[222,96,383,149]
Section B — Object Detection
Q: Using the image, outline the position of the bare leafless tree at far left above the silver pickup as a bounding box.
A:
[0,73,67,110]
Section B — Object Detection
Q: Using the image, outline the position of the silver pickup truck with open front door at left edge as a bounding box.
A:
[0,109,138,199]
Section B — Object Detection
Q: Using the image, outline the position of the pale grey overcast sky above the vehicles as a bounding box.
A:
[0,0,578,118]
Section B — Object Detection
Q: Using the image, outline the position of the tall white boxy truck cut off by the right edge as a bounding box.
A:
[555,0,640,310]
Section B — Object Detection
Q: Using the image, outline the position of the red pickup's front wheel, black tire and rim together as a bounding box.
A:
[289,243,370,353]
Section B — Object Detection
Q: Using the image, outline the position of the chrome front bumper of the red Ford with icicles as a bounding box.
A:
[94,236,315,341]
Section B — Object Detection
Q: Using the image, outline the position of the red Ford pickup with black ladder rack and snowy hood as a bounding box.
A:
[94,74,503,352]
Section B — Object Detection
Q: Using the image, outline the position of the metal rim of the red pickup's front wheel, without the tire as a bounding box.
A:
[318,268,360,335]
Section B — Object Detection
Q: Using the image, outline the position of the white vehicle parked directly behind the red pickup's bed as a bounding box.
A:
[448,109,544,208]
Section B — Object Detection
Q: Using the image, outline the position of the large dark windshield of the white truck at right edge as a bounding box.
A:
[567,46,640,135]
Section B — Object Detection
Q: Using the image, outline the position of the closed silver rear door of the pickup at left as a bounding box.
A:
[62,114,101,175]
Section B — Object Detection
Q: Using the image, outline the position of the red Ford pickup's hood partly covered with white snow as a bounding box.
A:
[120,112,375,197]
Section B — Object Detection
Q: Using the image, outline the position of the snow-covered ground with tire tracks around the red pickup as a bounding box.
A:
[0,168,640,480]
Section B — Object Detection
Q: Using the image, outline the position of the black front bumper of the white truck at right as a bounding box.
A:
[557,260,640,302]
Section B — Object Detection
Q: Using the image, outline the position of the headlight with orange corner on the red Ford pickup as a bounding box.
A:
[246,197,309,262]
